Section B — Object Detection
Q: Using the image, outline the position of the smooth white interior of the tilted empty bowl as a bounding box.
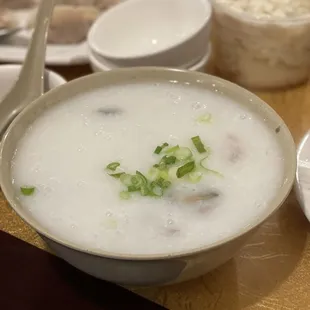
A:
[88,0,211,59]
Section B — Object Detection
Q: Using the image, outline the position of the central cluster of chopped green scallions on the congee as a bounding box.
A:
[107,136,222,199]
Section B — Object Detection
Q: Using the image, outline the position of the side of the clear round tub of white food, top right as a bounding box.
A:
[211,0,310,89]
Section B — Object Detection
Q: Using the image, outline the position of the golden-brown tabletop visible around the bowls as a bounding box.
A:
[0,66,310,310]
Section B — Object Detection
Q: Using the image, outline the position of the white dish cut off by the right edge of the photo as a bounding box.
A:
[295,131,310,221]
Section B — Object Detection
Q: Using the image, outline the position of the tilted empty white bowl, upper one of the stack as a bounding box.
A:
[88,0,212,67]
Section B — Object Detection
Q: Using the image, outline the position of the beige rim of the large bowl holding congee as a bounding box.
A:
[0,67,297,261]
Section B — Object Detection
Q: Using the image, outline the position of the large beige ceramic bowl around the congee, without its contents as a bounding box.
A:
[0,68,296,286]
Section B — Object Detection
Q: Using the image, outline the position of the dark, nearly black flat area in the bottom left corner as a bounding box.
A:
[0,231,165,310]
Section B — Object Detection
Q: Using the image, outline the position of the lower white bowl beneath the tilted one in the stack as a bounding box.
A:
[88,45,211,72]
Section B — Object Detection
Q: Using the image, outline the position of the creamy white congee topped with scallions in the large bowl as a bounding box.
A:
[12,81,284,254]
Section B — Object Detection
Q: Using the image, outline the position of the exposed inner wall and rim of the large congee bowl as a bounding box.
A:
[0,67,296,260]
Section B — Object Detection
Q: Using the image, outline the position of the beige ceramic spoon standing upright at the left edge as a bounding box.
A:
[0,0,55,138]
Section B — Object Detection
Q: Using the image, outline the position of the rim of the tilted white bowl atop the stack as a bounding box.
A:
[87,0,212,62]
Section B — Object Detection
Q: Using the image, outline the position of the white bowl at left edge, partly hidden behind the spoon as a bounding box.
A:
[0,65,67,101]
